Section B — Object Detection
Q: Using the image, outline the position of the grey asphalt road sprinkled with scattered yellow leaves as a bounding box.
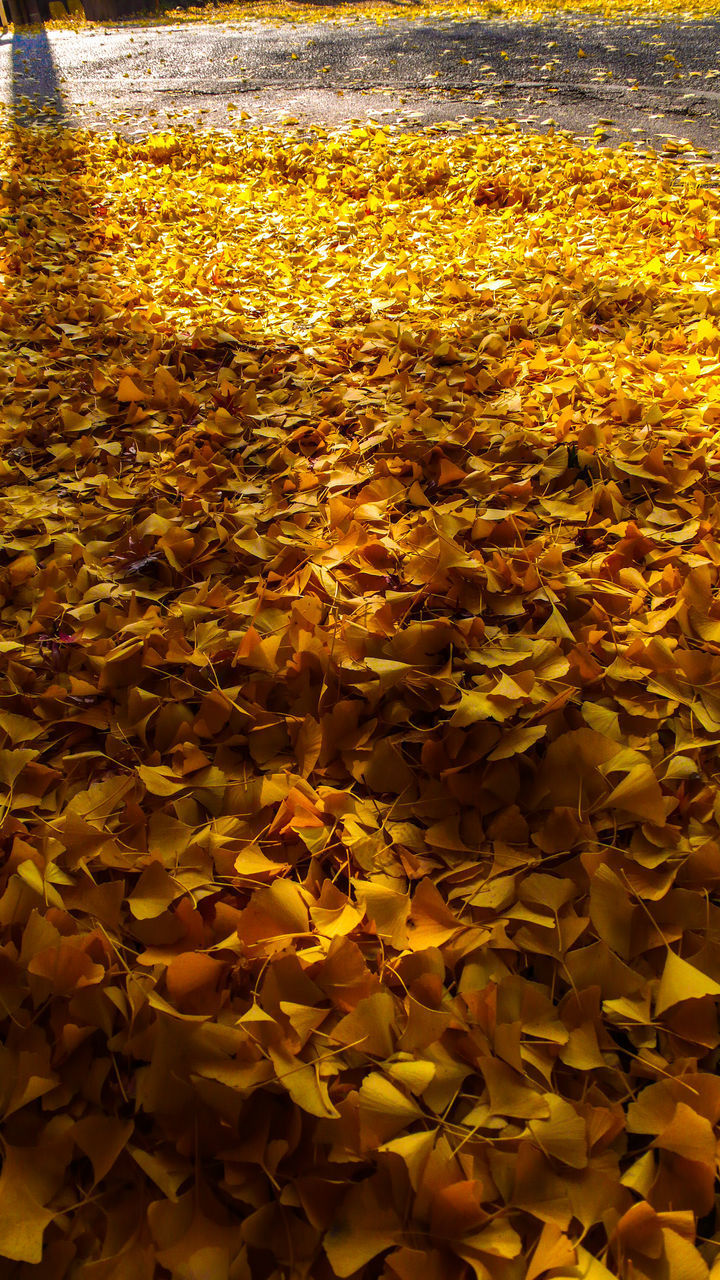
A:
[0,9,720,160]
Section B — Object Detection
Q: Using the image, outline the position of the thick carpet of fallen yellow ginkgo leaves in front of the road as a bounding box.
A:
[0,115,720,1280]
